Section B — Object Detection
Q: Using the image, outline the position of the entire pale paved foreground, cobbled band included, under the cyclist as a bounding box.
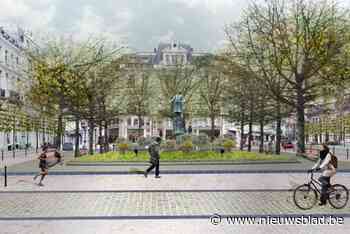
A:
[0,173,350,234]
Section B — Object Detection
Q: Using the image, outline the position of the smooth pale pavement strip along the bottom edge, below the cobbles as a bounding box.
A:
[0,219,350,234]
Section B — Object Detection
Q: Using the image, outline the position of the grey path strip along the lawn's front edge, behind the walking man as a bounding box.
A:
[4,160,350,175]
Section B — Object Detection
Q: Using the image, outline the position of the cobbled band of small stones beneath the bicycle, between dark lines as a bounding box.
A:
[0,191,350,219]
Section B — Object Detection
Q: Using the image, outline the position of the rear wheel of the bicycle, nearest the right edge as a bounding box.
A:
[328,184,349,209]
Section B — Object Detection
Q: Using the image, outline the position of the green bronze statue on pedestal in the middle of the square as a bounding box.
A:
[171,93,185,144]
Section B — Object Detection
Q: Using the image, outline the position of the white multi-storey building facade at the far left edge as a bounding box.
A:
[0,27,52,151]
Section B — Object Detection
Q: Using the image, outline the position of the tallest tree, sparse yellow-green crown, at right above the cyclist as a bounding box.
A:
[224,0,349,153]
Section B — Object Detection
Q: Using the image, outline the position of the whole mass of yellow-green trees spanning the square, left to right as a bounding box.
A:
[28,0,350,157]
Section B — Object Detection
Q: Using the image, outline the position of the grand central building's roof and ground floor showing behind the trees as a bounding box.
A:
[109,41,239,140]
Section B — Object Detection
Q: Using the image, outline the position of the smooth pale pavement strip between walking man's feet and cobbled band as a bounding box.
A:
[0,173,350,191]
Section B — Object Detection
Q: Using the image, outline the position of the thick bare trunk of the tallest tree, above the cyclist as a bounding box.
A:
[296,76,305,155]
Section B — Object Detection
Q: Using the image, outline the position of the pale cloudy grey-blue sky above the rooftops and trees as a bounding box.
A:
[0,0,247,50]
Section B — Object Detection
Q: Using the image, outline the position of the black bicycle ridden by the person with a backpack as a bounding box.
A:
[293,171,349,210]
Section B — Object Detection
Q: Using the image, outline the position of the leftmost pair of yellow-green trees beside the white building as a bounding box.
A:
[28,38,120,154]
